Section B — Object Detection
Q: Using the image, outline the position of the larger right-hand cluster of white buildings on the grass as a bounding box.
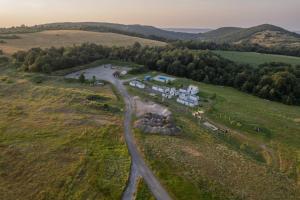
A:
[152,85,199,107]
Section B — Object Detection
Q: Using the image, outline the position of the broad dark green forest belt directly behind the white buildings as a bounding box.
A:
[13,43,300,105]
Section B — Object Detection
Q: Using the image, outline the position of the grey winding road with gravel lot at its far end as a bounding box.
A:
[66,66,171,200]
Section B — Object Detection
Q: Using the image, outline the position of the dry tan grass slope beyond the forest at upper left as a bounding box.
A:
[0,30,165,54]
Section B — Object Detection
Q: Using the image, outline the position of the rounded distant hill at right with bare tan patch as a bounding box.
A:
[198,24,300,47]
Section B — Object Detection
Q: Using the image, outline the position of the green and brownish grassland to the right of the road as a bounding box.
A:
[128,75,300,199]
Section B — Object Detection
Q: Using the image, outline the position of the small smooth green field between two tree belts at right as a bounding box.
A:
[213,51,300,65]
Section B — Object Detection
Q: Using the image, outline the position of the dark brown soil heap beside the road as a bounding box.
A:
[135,113,180,135]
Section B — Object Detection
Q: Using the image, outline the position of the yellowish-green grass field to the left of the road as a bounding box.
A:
[0,68,130,200]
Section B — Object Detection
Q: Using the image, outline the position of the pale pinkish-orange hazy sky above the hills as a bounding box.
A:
[0,0,300,30]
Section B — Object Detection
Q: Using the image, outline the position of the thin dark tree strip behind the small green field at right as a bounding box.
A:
[172,40,300,57]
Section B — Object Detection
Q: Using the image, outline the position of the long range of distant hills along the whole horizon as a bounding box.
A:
[0,22,300,47]
